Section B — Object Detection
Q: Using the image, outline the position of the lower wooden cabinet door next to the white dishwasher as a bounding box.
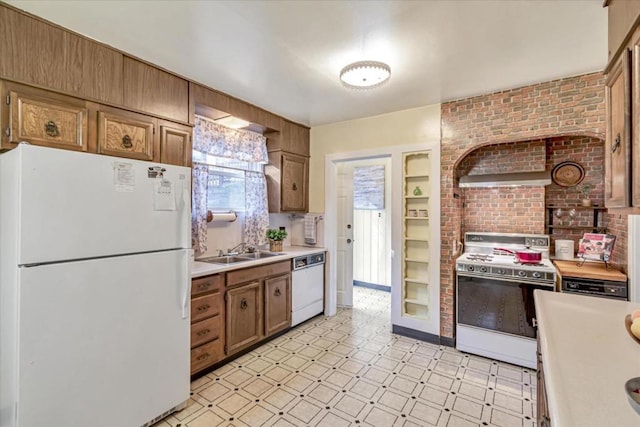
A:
[264,274,291,336]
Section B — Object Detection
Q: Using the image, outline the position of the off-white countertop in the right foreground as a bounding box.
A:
[534,291,640,427]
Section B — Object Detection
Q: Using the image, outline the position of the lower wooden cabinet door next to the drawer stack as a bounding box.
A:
[226,281,262,355]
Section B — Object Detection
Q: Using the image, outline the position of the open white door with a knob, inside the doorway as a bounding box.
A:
[336,163,353,307]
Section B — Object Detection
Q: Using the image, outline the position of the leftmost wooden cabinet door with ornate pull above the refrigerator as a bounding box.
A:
[2,83,87,151]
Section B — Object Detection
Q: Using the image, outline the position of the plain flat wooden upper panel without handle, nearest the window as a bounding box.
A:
[124,56,189,123]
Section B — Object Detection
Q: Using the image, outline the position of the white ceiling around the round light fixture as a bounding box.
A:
[8,0,607,126]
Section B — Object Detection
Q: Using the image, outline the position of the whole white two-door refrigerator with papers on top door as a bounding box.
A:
[0,144,191,427]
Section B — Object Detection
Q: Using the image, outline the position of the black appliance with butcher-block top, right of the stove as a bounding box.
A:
[553,260,629,301]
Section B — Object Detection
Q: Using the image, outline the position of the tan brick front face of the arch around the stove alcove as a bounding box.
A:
[440,73,605,337]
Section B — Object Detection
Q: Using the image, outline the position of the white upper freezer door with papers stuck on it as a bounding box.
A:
[6,144,191,265]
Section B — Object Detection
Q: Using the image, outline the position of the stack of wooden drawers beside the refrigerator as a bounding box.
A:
[191,274,225,375]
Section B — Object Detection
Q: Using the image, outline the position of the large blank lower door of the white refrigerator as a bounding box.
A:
[16,250,190,427]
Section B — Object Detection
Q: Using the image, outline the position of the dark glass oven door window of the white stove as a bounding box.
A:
[457,275,552,338]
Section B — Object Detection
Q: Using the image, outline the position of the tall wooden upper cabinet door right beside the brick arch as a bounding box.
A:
[604,50,631,208]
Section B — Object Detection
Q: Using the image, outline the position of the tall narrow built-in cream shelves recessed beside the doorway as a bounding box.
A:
[402,151,431,319]
